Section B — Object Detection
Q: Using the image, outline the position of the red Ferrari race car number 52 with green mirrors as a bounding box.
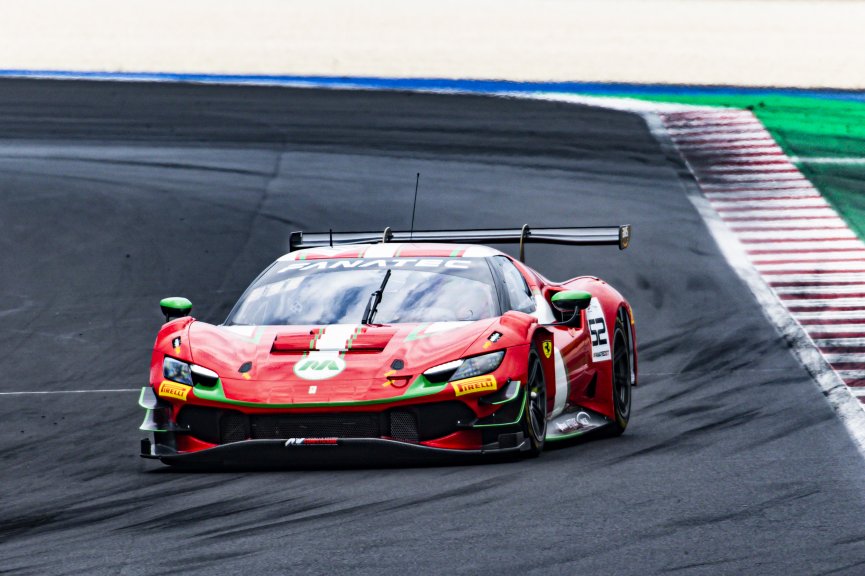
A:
[139,226,637,464]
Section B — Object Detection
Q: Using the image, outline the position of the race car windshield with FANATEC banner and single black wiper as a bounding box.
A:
[226,258,499,325]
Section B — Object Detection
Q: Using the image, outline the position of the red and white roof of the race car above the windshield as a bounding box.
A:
[279,242,502,261]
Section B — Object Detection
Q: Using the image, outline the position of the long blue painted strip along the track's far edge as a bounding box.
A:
[0,70,865,101]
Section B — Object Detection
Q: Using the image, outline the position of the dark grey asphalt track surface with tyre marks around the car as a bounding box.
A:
[0,81,865,575]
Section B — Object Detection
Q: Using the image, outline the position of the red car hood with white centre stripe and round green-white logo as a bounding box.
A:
[189,318,498,404]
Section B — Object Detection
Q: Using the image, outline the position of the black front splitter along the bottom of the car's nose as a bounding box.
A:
[141,432,529,468]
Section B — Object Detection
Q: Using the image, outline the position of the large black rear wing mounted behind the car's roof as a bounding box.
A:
[289,224,631,261]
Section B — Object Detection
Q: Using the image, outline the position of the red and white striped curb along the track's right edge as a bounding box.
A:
[641,107,865,456]
